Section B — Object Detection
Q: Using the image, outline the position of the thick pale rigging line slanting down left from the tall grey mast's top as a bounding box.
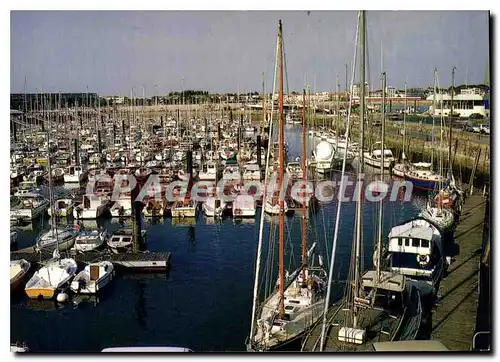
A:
[320,12,364,351]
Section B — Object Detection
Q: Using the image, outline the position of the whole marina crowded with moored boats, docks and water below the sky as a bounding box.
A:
[10,11,492,353]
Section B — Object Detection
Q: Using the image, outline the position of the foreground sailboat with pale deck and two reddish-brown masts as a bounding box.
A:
[247,20,326,351]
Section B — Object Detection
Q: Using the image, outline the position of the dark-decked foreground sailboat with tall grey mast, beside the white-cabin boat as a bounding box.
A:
[303,11,422,351]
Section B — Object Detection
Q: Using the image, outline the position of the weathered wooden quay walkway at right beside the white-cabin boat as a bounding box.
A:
[431,193,485,351]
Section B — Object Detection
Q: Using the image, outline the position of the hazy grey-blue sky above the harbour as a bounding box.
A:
[10,11,489,96]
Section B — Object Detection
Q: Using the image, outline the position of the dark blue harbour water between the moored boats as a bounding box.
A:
[11,127,424,352]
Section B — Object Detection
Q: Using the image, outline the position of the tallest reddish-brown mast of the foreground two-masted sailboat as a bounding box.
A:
[278,19,285,318]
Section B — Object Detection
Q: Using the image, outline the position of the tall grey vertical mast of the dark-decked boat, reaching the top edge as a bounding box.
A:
[353,10,366,328]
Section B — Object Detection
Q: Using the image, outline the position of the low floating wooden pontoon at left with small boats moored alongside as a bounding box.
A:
[10,247,172,272]
